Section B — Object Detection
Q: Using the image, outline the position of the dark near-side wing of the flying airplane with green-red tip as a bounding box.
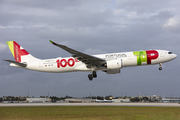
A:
[50,40,106,68]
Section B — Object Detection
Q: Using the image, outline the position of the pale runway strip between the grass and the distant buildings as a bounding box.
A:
[0,103,180,107]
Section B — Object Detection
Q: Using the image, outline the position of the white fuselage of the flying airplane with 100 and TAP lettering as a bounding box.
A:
[11,50,177,73]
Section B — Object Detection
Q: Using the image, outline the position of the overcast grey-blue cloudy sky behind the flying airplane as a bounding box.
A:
[0,0,180,97]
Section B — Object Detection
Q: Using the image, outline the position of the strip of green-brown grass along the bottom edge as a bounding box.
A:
[0,106,180,120]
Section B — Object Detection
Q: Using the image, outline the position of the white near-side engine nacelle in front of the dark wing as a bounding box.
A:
[106,59,122,69]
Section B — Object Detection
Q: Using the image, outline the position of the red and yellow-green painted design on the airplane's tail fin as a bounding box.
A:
[7,41,29,62]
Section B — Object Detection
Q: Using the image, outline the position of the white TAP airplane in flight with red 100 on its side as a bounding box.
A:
[4,40,177,81]
